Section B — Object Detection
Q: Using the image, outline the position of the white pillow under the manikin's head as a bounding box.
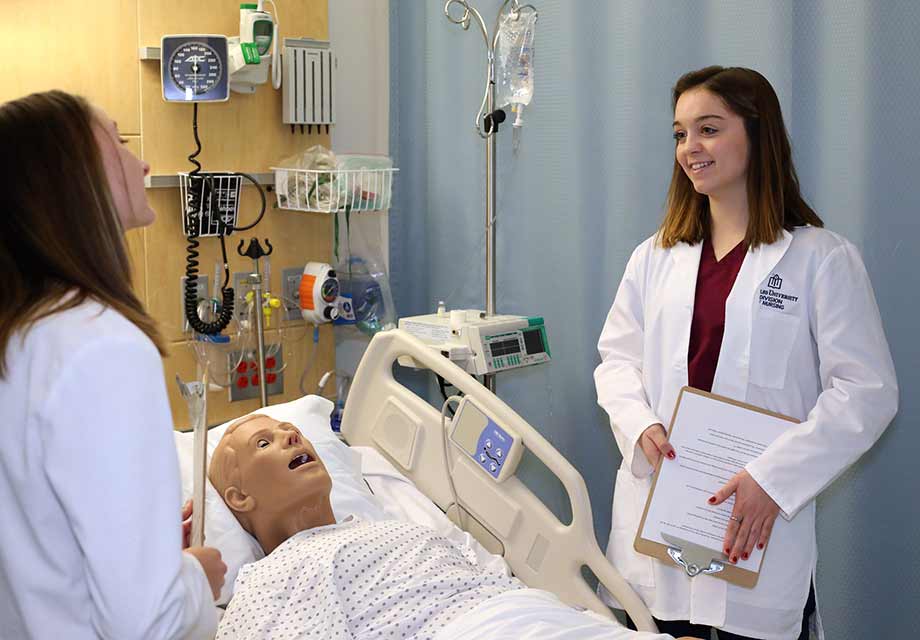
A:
[175,396,386,604]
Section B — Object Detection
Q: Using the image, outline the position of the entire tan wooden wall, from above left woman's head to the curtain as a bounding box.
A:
[0,0,335,426]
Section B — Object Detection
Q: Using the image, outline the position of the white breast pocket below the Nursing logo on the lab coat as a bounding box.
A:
[749,309,801,389]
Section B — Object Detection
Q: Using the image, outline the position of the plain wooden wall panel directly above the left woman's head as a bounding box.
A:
[0,0,140,134]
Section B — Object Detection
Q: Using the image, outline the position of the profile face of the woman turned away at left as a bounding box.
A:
[93,108,156,231]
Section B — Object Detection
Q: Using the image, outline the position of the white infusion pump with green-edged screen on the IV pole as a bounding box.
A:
[399,307,550,375]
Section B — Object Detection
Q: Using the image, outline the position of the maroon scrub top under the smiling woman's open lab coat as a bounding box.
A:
[687,238,747,391]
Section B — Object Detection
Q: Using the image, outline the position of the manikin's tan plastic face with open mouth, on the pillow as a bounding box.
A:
[212,415,332,515]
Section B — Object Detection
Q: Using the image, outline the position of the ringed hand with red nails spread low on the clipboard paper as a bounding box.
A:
[709,469,779,563]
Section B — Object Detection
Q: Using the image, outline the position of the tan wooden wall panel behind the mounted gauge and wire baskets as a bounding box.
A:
[138,0,335,428]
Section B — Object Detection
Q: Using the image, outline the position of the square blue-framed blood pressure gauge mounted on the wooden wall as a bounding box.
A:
[160,35,230,102]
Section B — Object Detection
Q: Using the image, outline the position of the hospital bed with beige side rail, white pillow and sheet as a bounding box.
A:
[177,330,656,632]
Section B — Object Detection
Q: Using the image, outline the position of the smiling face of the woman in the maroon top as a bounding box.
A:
[674,88,750,198]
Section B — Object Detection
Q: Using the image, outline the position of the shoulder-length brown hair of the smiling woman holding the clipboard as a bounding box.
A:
[658,67,824,248]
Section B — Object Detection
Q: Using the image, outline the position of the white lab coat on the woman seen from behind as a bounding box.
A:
[0,301,217,640]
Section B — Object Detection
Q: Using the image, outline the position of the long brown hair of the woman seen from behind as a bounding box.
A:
[0,91,165,378]
